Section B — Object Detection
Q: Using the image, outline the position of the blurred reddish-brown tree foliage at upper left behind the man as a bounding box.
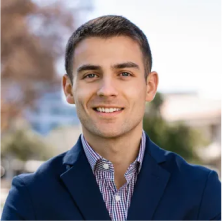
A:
[0,0,86,134]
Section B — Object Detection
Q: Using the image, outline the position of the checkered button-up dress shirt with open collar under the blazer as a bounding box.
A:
[81,131,146,221]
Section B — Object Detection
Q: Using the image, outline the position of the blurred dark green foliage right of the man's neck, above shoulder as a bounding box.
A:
[143,93,205,162]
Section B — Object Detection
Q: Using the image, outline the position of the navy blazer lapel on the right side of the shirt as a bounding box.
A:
[127,136,170,221]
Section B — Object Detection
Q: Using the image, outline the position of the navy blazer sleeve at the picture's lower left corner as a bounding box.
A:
[1,176,35,221]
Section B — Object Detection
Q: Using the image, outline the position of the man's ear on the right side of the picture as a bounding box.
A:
[146,71,159,102]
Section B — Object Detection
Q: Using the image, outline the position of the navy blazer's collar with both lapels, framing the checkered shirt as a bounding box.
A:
[60,133,170,221]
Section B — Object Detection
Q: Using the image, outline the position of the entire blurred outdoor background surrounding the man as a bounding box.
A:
[0,0,222,217]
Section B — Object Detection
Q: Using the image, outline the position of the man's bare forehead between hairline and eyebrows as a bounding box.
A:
[73,36,143,69]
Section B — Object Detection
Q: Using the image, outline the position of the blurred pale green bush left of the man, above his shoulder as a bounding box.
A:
[0,130,53,161]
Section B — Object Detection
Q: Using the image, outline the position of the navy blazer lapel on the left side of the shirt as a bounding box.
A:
[60,138,110,221]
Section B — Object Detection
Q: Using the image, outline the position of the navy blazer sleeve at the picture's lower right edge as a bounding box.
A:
[198,171,222,221]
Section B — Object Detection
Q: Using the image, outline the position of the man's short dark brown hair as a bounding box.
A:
[65,15,152,81]
